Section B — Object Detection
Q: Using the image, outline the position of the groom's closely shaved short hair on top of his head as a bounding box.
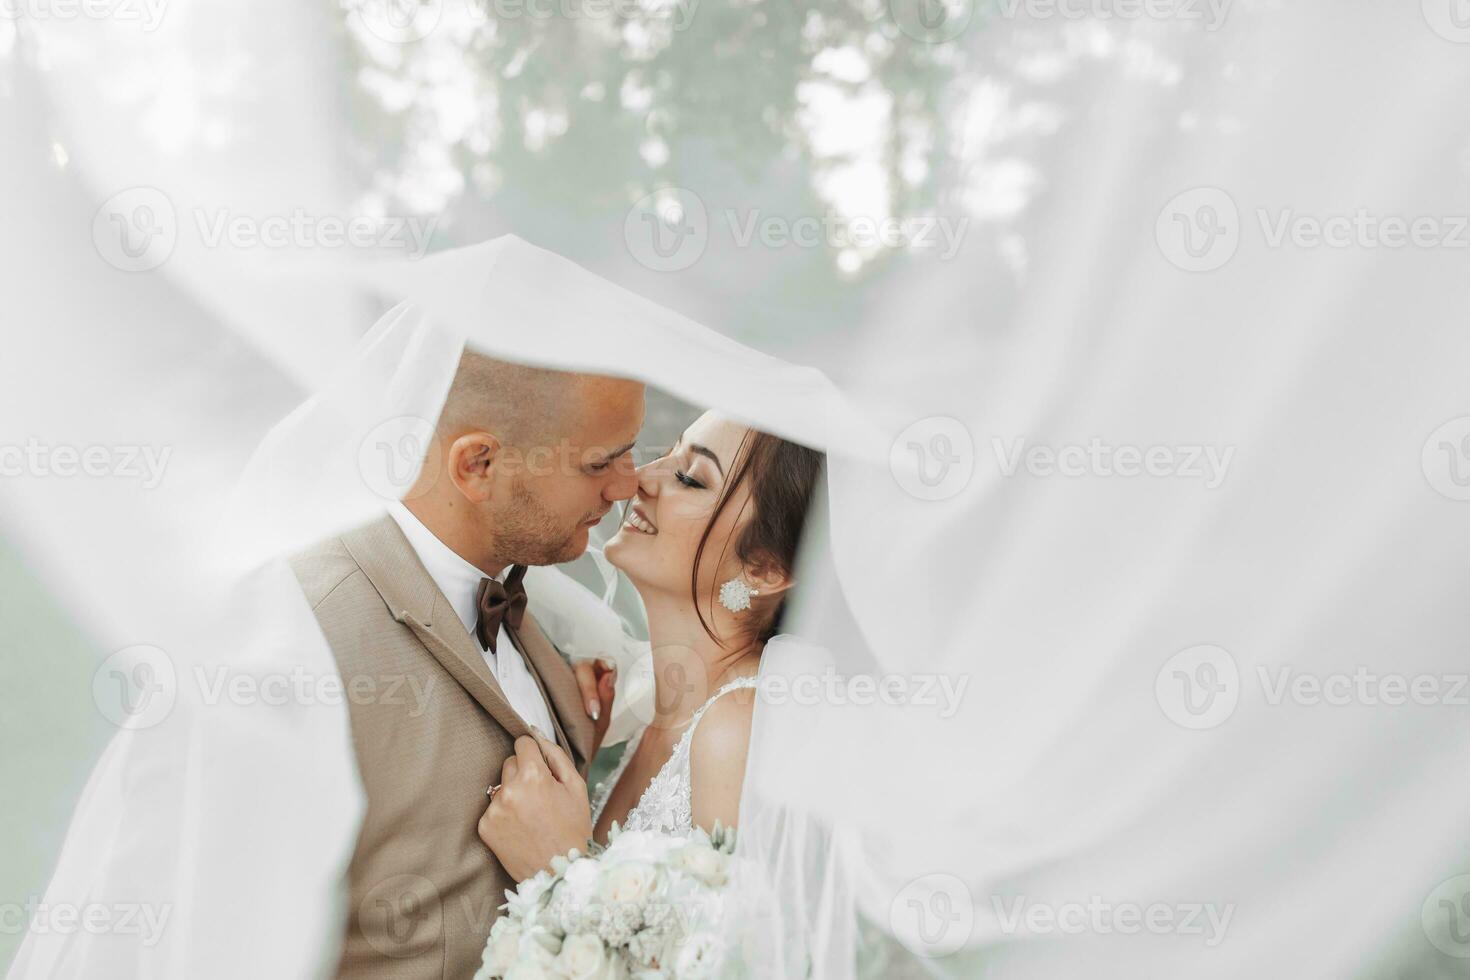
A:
[438,350,587,448]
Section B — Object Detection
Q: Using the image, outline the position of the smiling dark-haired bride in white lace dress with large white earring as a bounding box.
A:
[479,413,825,877]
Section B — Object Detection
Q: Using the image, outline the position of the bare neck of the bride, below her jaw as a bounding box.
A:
[644,595,763,729]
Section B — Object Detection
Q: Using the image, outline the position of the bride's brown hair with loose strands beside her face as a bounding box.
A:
[689,429,826,646]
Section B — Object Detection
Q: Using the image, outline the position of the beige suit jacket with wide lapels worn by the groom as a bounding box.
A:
[291,517,592,980]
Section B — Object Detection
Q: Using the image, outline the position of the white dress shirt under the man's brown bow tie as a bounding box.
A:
[388,502,556,741]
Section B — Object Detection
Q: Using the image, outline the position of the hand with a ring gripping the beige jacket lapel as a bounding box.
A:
[479,735,592,882]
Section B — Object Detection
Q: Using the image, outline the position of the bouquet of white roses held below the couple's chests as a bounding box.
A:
[475,826,735,980]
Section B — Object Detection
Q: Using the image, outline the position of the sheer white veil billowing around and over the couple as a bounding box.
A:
[0,0,1470,980]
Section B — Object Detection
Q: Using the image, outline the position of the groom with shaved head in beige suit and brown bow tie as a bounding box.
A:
[291,351,644,980]
